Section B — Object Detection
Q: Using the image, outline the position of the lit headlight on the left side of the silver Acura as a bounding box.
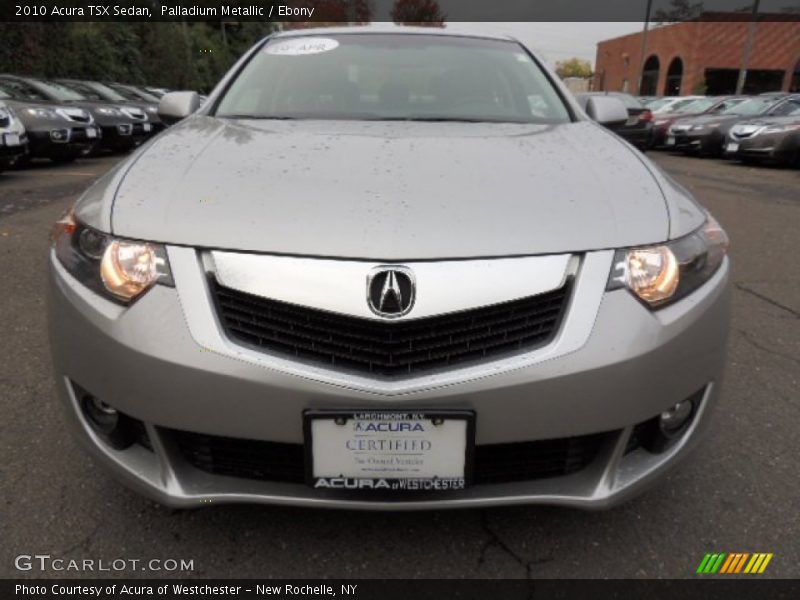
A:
[51,213,174,304]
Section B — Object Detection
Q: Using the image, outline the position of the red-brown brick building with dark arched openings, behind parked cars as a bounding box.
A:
[594,14,800,96]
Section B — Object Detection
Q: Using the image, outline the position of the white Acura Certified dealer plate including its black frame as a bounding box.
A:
[304,411,468,491]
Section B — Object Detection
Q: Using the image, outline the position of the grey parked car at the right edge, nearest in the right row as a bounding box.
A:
[725,95,800,166]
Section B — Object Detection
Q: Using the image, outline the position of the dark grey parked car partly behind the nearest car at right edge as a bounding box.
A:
[667,95,793,156]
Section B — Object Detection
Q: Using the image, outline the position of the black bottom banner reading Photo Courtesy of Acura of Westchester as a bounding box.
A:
[0,575,800,600]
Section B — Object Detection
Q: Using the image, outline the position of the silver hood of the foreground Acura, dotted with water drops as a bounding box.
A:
[92,115,692,260]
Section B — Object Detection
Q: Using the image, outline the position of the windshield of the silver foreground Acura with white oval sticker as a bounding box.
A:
[216,34,570,123]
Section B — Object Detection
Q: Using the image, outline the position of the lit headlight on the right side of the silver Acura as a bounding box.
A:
[607,215,728,308]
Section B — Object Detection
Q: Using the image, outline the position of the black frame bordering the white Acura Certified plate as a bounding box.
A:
[303,409,475,493]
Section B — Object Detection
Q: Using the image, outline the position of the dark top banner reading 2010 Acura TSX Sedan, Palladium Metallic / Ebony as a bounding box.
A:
[0,0,800,24]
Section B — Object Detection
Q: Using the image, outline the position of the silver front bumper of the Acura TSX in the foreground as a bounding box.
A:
[49,251,730,510]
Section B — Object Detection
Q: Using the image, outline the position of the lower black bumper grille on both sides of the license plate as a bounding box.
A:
[169,430,611,485]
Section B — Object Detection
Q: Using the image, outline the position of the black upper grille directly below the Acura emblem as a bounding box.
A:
[212,282,570,377]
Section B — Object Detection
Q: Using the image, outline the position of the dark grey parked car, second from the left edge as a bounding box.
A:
[0,80,102,163]
